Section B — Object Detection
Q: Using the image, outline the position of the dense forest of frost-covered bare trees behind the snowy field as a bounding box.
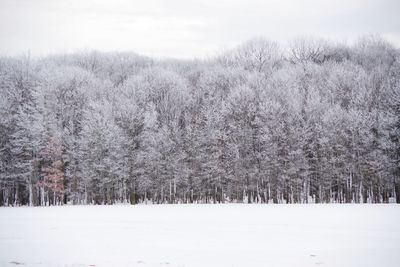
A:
[0,35,400,206]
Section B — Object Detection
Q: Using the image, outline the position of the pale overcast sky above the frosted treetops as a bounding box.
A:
[0,0,400,58]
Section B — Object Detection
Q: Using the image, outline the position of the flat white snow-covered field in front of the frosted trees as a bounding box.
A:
[0,204,400,267]
